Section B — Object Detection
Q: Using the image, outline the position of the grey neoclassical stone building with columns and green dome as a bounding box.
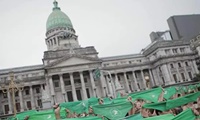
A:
[0,1,199,116]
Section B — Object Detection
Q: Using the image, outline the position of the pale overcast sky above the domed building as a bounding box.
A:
[0,0,200,69]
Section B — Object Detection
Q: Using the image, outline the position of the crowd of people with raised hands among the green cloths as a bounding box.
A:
[19,85,200,120]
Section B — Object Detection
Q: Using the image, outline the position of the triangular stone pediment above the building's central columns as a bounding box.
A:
[46,54,101,67]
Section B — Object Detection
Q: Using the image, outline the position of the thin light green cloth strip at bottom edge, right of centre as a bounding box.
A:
[143,114,174,120]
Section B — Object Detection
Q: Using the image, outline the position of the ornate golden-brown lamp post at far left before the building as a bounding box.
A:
[1,72,24,116]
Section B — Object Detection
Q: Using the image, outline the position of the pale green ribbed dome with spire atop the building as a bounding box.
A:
[46,1,73,31]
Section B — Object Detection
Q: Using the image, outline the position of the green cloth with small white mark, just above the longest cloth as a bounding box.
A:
[129,87,162,103]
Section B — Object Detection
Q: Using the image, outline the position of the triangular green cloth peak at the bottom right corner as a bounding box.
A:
[172,109,196,120]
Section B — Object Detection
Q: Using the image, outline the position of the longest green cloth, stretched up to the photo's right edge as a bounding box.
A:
[143,92,200,111]
